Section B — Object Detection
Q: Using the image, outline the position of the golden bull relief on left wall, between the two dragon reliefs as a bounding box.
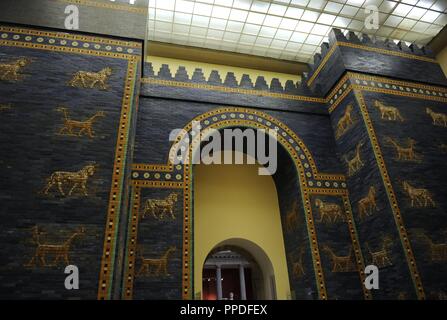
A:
[43,163,98,197]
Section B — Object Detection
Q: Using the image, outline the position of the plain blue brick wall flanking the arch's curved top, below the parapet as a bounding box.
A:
[134,97,341,173]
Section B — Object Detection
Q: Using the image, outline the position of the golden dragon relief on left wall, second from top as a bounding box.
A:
[56,107,105,139]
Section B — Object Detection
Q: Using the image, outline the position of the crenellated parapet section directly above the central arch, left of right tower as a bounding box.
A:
[140,62,327,114]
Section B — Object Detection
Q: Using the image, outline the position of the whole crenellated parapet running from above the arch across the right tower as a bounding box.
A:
[141,29,447,110]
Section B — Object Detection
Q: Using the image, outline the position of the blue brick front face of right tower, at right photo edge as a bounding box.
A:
[364,92,447,299]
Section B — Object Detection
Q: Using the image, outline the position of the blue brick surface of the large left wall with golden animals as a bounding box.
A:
[0,27,138,299]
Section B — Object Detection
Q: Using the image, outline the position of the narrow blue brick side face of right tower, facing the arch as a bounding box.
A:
[331,93,415,299]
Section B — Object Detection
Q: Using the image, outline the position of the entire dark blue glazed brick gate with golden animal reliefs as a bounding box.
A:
[0,15,447,299]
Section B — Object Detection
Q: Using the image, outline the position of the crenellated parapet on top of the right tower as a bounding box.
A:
[303,29,447,95]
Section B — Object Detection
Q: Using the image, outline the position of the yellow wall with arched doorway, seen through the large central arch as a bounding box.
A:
[193,158,290,300]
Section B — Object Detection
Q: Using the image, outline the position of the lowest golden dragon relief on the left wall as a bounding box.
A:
[25,226,85,267]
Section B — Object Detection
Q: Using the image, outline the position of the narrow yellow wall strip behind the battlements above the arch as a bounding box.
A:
[147,56,300,86]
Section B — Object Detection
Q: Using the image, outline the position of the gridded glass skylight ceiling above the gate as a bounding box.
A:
[148,0,447,62]
